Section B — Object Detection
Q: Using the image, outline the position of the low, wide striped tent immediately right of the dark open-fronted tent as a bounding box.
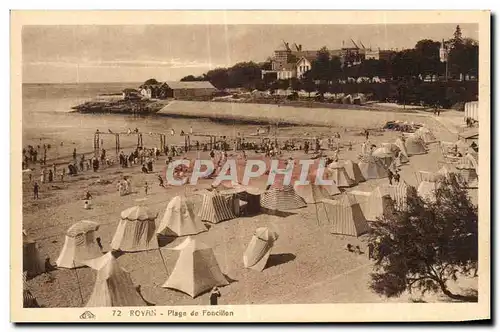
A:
[260,185,307,211]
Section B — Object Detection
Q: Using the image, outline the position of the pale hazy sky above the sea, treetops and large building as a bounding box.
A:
[22,23,478,83]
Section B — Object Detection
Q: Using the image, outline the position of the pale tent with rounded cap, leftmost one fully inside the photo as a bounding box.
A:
[56,220,102,269]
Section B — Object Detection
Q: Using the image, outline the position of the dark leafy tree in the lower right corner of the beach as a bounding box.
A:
[371,176,478,301]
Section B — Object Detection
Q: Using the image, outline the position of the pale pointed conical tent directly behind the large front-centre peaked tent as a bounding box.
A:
[156,196,207,236]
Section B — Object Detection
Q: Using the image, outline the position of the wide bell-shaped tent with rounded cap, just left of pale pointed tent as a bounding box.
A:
[111,205,158,252]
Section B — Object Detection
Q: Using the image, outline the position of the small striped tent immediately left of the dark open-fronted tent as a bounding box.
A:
[199,190,236,224]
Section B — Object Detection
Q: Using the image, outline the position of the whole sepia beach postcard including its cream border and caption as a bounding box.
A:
[11,11,490,322]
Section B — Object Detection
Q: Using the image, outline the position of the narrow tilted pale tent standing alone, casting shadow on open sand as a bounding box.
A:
[243,227,278,271]
